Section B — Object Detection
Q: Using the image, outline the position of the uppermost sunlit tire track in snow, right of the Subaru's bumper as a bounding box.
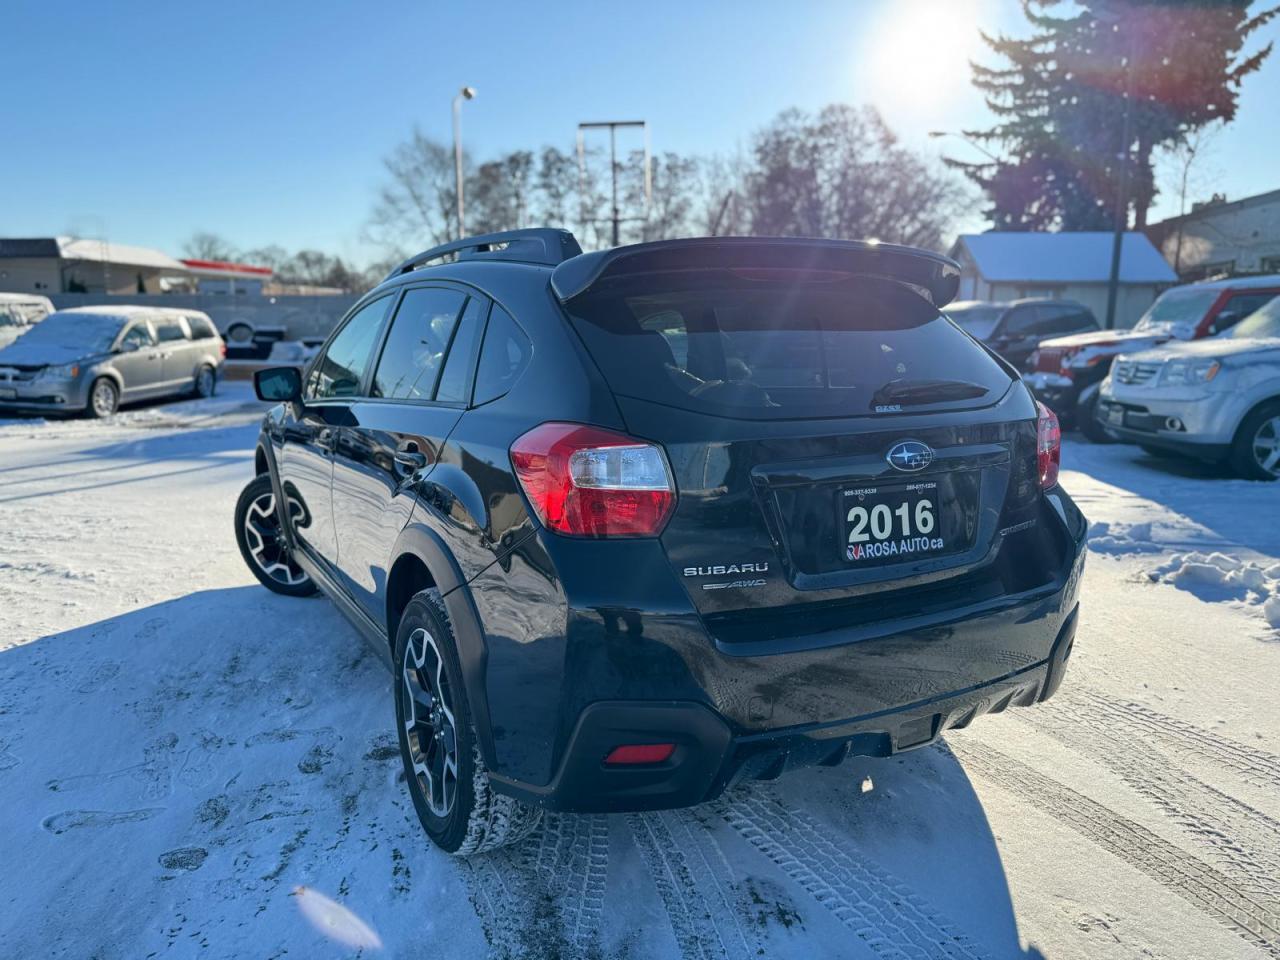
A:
[1038,689,1280,790]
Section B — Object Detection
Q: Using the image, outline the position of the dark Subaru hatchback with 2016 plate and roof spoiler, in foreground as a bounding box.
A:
[236,229,1085,854]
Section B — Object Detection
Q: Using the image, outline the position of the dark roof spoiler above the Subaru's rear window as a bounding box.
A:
[552,237,960,307]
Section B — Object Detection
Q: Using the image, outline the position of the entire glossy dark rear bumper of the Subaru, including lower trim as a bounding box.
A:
[476,489,1087,812]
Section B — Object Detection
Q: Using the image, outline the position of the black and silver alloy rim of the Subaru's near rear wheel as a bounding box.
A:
[401,627,458,818]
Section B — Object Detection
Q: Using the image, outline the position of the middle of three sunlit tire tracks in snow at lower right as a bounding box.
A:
[1018,710,1280,914]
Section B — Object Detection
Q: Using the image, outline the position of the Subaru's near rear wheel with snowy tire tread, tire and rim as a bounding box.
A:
[394,590,543,856]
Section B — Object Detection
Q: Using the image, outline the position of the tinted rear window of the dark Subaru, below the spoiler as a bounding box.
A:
[567,270,1011,420]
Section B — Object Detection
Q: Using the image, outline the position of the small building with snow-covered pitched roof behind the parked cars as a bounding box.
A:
[951,232,1178,328]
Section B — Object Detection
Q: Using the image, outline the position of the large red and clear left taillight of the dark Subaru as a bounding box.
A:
[511,424,676,536]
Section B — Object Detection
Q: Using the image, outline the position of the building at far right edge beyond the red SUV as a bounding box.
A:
[1147,189,1280,280]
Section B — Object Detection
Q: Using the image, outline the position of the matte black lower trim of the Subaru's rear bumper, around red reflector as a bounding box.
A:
[494,611,1076,813]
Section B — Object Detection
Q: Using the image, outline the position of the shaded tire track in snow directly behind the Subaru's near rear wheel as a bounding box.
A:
[462,814,609,959]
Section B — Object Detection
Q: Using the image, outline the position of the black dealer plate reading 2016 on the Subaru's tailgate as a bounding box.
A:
[838,480,965,567]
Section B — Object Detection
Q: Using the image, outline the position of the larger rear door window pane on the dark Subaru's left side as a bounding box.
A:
[372,287,466,401]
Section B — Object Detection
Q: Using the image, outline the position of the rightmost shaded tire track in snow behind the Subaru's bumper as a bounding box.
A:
[718,795,980,960]
